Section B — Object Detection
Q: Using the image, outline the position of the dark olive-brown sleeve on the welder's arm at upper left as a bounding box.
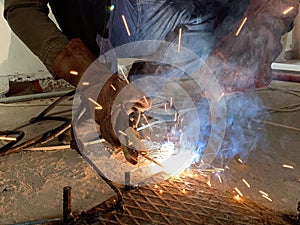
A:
[4,0,69,73]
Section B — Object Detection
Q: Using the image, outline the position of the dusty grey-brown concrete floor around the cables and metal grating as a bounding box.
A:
[0,81,300,224]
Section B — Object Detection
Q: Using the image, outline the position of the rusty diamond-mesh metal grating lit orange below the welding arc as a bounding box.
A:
[85,171,290,225]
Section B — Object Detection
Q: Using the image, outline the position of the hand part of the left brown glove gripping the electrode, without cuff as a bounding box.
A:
[95,74,151,164]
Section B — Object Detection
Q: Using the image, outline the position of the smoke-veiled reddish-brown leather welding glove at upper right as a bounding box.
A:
[200,0,299,92]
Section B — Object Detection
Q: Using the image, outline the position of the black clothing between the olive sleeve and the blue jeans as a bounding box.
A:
[49,0,110,56]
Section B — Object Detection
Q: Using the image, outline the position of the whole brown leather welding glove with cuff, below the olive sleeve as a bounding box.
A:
[53,39,151,164]
